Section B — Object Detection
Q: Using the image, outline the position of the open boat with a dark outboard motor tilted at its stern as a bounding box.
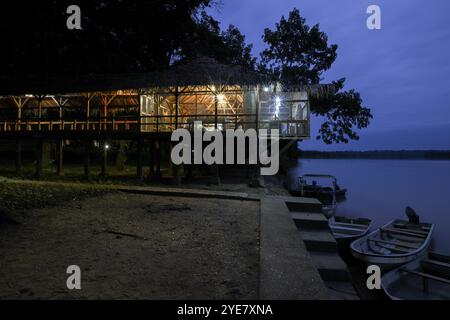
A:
[350,219,434,270]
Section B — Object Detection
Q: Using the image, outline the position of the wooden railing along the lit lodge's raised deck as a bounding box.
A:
[0,114,310,137]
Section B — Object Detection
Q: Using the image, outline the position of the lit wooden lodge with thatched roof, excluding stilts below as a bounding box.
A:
[0,58,332,139]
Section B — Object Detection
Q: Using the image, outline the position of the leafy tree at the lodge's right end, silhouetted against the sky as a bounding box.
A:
[259,9,372,144]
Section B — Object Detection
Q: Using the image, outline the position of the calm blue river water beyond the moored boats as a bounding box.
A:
[290,159,450,254]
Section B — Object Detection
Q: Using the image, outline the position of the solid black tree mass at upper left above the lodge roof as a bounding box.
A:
[0,0,212,76]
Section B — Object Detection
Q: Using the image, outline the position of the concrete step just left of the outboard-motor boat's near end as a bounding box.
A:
[309,251,350,281]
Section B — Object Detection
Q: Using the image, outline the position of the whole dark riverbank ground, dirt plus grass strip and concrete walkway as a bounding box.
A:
[0,175,335,299]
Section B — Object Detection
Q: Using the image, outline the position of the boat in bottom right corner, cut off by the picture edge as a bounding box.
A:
[381,252,450,300]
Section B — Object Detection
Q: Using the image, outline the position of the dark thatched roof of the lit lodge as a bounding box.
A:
[0,58,329,96]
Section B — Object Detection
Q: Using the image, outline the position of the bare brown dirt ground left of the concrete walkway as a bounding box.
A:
[0,193,259,299]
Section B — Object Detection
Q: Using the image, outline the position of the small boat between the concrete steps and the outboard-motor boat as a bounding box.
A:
[328,216,372,247]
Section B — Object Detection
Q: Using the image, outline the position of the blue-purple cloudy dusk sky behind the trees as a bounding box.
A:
[210,0,450,150]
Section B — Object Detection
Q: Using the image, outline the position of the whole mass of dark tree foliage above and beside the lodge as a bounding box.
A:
[0,0,372,144]
